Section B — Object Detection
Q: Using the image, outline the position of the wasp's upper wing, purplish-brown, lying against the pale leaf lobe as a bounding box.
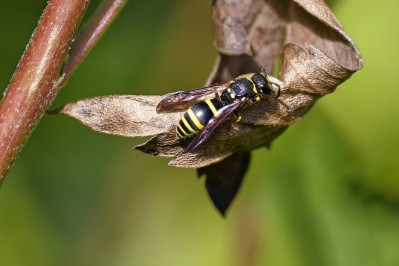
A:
[157,83,228,113]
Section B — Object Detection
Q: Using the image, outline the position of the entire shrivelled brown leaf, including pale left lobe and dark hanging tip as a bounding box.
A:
[53,0,363,212]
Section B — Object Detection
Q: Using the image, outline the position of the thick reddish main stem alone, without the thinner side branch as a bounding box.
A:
[0,0,89,184]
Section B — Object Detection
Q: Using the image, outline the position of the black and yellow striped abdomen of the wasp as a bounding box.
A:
[176,98,223,138]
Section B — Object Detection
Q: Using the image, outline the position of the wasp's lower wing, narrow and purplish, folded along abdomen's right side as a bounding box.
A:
[183,101,245,153]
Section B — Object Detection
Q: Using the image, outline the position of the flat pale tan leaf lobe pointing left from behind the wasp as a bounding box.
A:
[49,95,181,137]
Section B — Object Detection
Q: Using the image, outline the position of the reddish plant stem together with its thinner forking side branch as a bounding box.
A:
[0,0,127,185]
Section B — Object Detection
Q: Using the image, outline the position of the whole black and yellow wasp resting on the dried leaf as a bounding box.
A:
[157,67,280,153]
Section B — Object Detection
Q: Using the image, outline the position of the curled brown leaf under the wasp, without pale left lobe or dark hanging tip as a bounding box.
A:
[137,0,362,168]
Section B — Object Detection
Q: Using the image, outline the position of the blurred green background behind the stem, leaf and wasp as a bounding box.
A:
[0,0,399,266]
